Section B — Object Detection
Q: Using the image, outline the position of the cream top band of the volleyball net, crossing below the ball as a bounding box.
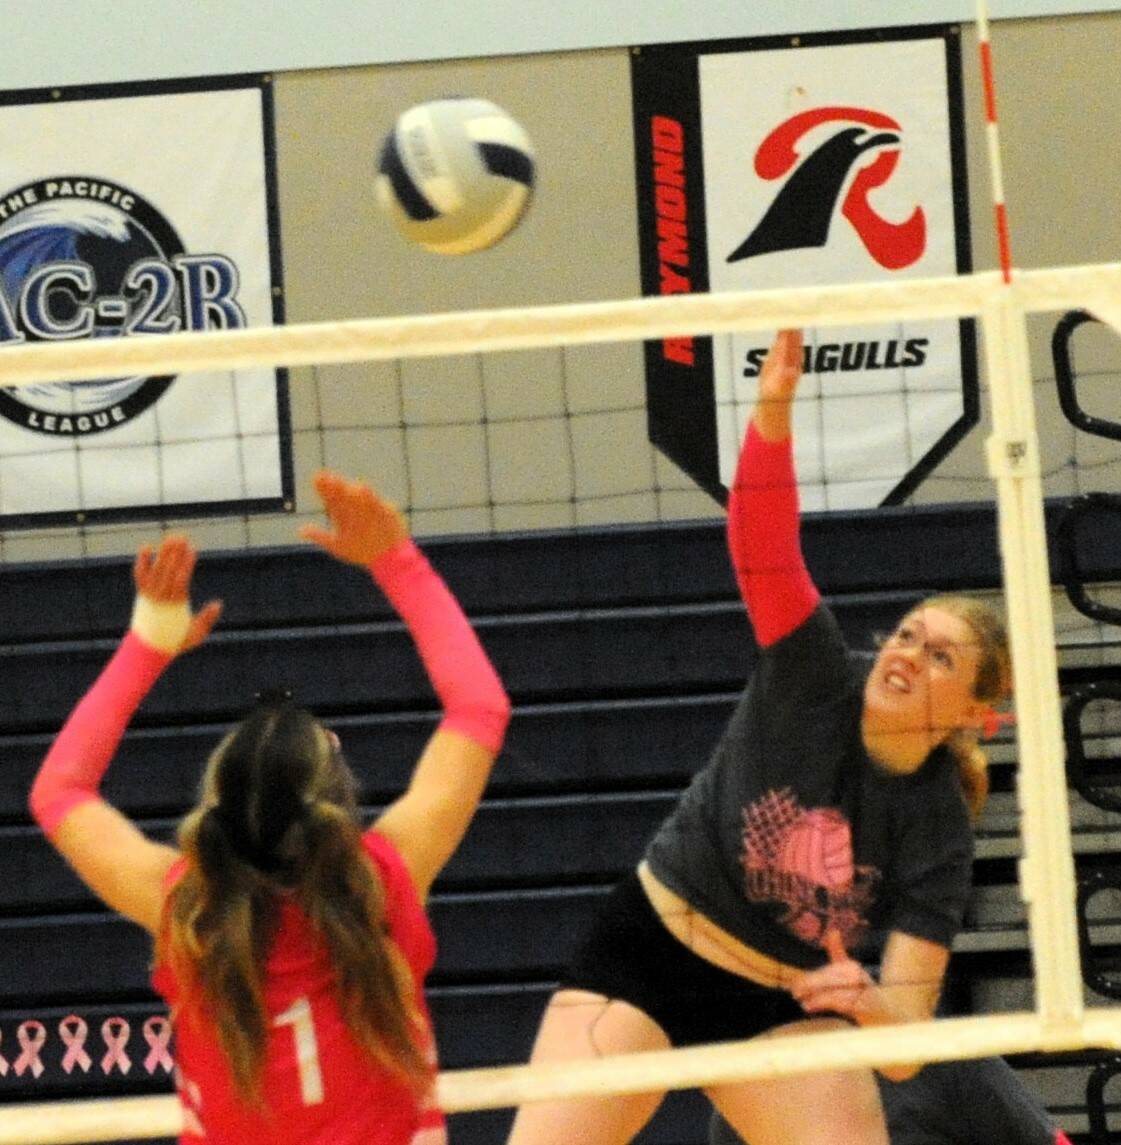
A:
[0,263,1121,386]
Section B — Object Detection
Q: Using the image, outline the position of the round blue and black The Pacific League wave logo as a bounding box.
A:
[0,175,246,436]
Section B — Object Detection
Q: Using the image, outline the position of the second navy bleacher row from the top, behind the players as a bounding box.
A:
[0,593,929,732]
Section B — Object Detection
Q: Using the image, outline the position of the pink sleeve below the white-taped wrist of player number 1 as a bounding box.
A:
[29,632,172,836]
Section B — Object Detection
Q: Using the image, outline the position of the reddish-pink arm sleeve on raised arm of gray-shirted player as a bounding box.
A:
[728,423,821,648]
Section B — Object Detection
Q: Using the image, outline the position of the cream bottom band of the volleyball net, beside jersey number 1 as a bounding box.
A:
[0,1008,1121,1145]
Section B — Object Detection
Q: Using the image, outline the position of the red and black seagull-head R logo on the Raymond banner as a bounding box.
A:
[727,108,926,270]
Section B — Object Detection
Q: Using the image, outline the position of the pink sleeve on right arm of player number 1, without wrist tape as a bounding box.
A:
[370,540,510,755]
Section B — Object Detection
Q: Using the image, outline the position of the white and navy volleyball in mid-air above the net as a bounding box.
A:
[377,98,534,254]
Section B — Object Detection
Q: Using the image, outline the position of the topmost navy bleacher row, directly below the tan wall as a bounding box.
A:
[0,503,1121,642]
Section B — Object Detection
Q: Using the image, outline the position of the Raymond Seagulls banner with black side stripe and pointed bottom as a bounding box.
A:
[632,27,978,510]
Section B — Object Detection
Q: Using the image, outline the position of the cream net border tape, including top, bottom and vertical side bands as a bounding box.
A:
[0,264,1121,1145]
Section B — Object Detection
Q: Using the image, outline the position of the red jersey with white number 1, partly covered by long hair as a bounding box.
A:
[152,831,447,1145]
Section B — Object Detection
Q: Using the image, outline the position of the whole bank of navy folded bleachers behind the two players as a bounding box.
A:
[0,506,1121,1145]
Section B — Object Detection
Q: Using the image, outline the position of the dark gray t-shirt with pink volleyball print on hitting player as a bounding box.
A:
[646,605,973,969]
